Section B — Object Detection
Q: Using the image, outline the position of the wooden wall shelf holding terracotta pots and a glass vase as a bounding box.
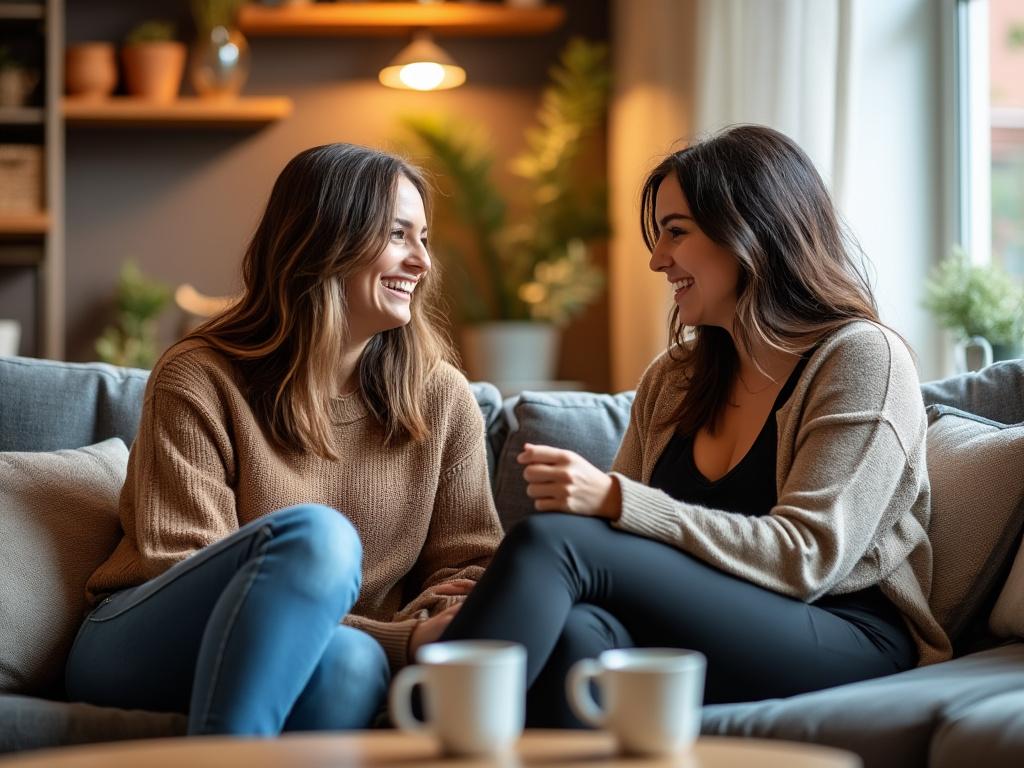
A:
[62,96,292,128]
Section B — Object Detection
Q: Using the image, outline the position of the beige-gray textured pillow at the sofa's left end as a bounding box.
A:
[0,437,128,693]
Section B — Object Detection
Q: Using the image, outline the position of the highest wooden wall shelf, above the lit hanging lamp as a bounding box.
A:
[239,2,565,37]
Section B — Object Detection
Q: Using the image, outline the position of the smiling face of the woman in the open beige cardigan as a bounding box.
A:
[650,173,739,332]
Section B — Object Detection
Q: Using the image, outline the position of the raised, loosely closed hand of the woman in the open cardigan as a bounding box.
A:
[516,442,622,520]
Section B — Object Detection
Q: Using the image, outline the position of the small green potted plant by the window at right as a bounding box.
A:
[924,249,1024,369]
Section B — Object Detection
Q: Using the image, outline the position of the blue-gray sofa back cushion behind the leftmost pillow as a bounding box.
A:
[0,357,148,451]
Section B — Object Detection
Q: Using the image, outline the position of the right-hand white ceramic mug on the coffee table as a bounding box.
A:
[565,648,707,755]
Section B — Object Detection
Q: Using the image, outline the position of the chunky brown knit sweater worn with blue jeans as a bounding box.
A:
[86,341,502,668]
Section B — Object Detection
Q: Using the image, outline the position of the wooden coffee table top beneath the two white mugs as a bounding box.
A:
[0,730,861,768]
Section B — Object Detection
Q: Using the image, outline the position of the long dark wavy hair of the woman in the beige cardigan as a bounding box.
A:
[640,125,880,434]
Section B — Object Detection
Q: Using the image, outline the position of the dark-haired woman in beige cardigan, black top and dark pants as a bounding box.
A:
[444,126,950,726]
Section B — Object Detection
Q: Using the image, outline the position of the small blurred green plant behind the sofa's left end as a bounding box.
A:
[96,261,171,368]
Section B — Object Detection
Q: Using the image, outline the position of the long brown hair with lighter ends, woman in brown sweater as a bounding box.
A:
[188,143,453,459]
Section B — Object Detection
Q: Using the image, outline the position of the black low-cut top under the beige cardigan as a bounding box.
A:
[650,350,907,652]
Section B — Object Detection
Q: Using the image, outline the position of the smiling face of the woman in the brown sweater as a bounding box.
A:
[345,176,430,344]
